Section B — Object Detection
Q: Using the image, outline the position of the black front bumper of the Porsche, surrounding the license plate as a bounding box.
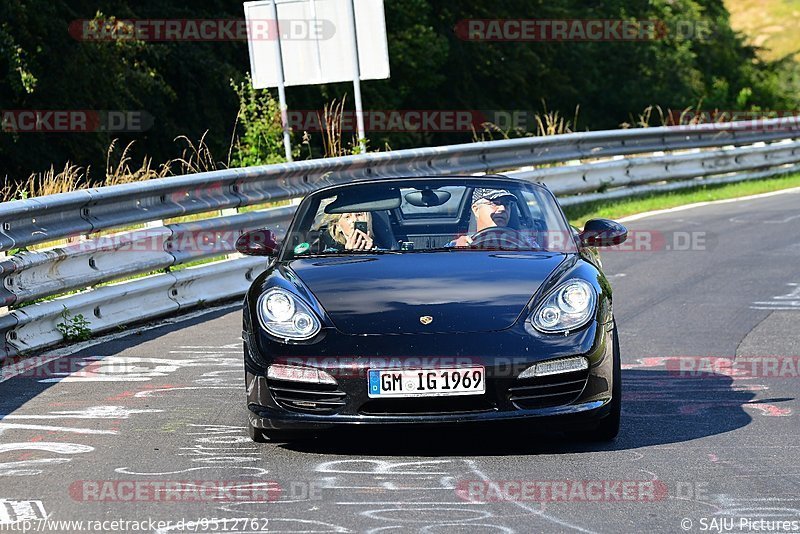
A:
[245,322,614,430]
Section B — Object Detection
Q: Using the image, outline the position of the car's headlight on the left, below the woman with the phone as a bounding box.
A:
[258,289,322,340]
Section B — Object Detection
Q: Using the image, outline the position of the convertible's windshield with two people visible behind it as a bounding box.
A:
[283,178,576,259]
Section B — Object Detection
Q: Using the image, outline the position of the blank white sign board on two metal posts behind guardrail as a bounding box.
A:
[244,0,389,89]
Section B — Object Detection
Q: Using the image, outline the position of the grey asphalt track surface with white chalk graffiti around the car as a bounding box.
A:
[0,191,800,533]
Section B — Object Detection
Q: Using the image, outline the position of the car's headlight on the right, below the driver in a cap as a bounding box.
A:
[531,278,597,334]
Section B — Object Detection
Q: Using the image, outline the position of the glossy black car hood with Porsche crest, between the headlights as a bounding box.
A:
[288,251,565,334]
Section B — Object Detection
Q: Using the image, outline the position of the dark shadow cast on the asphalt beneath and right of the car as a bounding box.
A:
[281,369,793,456]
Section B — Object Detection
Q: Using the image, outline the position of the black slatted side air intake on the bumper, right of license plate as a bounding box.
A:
[508,369,589,410]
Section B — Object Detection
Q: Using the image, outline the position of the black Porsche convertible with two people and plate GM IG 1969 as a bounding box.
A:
[237,176,627,441]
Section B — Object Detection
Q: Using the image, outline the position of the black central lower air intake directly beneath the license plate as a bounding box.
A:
[359,395,495,415]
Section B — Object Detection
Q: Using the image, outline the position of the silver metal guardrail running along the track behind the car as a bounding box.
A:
[0,119,800,360]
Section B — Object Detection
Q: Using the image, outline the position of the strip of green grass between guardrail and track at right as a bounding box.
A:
[564,174,800,228]
